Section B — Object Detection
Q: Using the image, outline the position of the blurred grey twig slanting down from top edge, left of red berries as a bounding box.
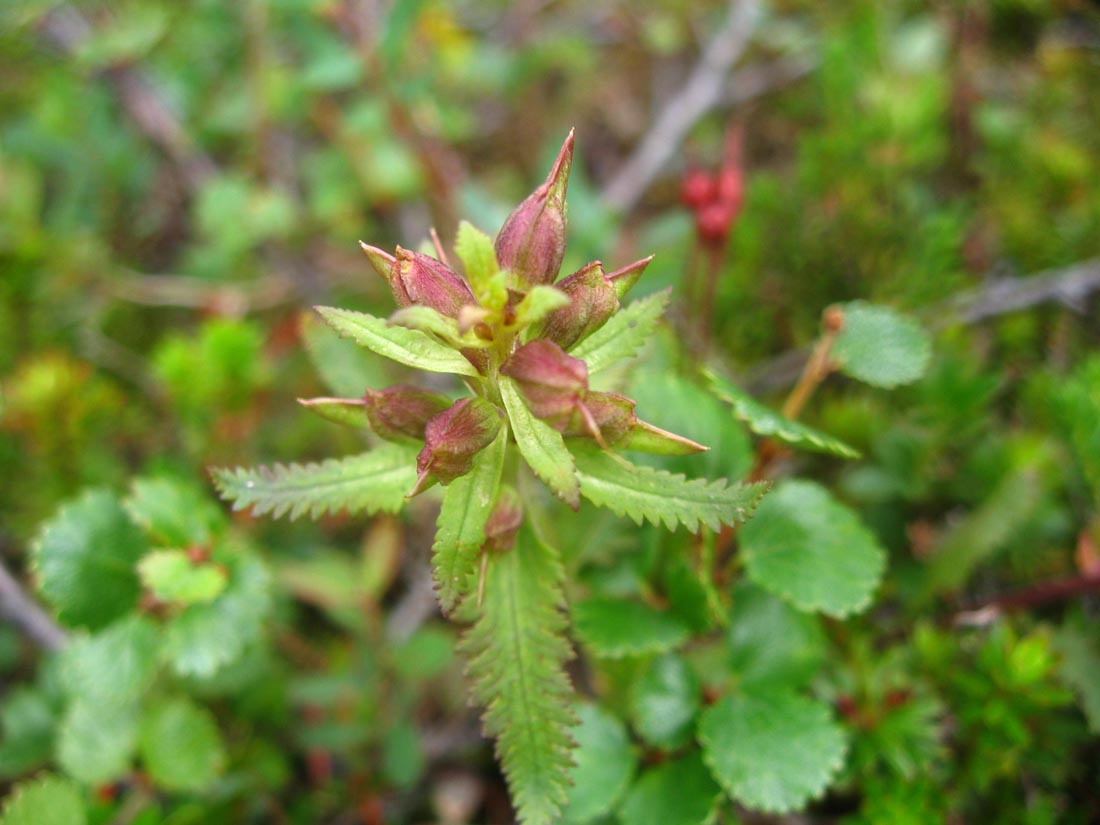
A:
[603,0,759,212]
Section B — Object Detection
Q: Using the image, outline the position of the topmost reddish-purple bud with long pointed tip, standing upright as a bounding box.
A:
[495,131,573,285]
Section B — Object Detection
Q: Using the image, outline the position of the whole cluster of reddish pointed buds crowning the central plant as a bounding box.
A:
[304,133,705,510]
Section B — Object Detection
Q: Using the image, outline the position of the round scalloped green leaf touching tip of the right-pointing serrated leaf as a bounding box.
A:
[740,481,886,618]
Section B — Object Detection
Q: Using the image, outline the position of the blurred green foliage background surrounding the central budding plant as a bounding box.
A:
[0,0,1100,825]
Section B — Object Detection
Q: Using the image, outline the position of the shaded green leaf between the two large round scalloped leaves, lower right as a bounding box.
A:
[726,582,826,689]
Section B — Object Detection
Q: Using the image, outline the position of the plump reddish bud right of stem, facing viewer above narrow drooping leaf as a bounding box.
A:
[501,338,589,429]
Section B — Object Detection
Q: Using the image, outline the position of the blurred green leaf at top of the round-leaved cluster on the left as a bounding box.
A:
[123,477,224,547]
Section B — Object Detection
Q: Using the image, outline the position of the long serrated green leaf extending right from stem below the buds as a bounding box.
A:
[572,442,768,532]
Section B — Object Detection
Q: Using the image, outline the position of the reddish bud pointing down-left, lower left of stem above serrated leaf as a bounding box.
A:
[408,398,503,497]
